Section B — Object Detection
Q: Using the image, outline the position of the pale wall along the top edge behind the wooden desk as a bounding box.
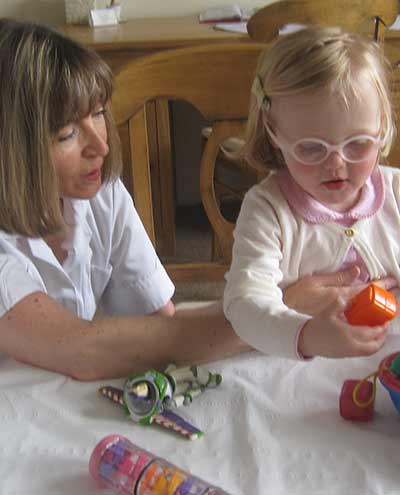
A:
[0,0,271,24]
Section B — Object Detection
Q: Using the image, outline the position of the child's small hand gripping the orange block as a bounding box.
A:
[298,298,387,358]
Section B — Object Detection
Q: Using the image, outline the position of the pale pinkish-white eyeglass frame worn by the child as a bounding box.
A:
[264,122,385,167]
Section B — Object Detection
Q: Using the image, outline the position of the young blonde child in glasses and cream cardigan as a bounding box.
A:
[224,28,400,359]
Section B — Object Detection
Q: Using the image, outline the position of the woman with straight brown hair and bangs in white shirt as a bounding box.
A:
[0,20,250,380]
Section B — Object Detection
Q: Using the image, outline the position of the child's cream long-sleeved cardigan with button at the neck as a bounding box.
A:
[224,167,400,359]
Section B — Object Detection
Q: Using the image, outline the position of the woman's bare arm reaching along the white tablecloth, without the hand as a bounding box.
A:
[0,292,249,380]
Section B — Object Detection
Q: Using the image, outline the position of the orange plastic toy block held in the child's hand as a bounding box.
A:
[344,284,397,327]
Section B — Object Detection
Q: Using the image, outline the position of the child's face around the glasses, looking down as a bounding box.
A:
[271,77,381,211]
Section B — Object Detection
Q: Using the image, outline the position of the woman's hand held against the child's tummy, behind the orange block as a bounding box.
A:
[283,266,397,316]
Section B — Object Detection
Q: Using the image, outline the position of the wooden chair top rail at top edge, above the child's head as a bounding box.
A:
[247,0,399,43]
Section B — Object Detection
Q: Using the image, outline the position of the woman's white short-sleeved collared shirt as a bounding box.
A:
[0,180,174,320]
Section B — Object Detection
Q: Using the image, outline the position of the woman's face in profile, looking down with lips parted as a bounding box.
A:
[50,105,109,199]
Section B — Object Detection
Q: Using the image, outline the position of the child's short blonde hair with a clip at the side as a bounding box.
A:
[240,27,395,172]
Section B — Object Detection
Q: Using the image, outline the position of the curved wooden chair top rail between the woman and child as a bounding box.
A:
[112,42,265,124]
